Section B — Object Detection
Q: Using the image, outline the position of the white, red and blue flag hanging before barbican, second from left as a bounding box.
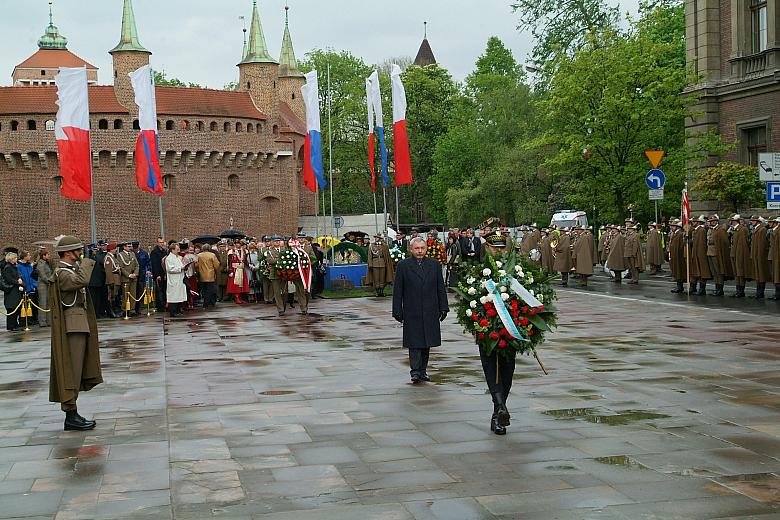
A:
[128,65,163,196]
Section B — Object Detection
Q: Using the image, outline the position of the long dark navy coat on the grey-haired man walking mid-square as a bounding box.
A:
[393,257,450,348]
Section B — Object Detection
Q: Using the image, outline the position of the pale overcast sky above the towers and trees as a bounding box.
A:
[0,0,637,88]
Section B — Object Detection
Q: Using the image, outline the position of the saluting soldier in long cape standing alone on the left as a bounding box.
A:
[49,236,103,430]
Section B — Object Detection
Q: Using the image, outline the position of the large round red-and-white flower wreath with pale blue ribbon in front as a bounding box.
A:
[456,250,557,358]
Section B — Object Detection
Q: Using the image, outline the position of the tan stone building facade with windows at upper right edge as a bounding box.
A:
[685,0,780,173]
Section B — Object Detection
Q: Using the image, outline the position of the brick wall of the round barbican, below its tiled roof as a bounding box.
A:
[0,112,304,251]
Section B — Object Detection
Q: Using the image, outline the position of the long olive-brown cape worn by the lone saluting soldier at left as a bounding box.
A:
[49,258,103,403]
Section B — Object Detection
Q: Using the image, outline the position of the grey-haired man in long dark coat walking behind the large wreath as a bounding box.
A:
[393,237,450,383]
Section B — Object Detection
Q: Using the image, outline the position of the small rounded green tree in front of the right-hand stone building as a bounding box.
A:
[693,161,764,213]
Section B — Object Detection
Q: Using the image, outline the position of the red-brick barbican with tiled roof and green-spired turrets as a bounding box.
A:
[0,0,316,247]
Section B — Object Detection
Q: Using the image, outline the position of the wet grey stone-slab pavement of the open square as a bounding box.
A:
[0,288,780,520]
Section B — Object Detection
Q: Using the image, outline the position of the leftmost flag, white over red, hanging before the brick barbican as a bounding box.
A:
[54,67,92,200]
